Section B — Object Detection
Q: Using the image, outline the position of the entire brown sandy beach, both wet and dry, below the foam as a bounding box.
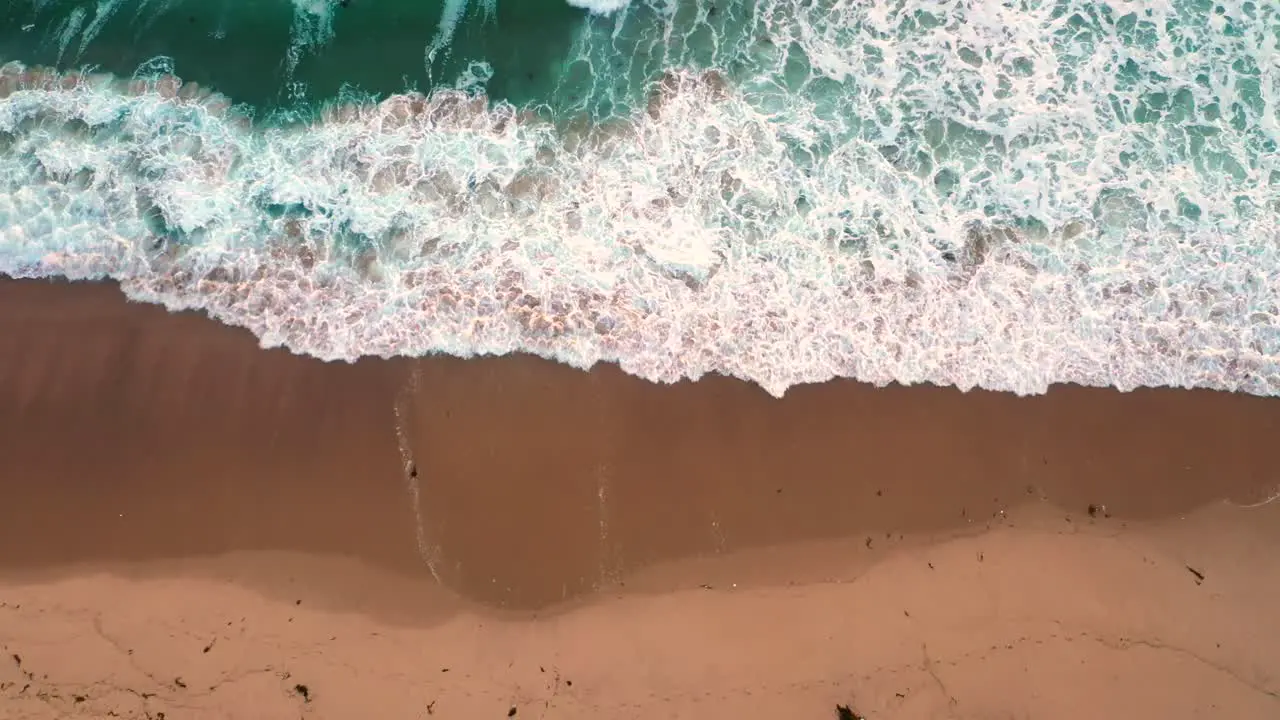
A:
[0,282,1280,720]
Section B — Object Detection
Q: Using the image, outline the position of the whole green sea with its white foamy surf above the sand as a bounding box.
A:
[0,0,1280,395]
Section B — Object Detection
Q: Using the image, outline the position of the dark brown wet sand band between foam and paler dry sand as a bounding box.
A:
[0,281,1280,610]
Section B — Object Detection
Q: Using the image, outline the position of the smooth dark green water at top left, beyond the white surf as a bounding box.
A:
[0,0,588,111]
